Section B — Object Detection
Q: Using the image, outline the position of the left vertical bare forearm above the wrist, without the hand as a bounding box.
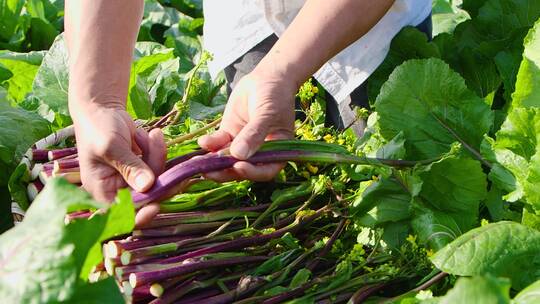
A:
[65,0,144,116]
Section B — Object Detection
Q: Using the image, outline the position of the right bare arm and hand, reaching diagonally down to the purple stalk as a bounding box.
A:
[199,0,394,181]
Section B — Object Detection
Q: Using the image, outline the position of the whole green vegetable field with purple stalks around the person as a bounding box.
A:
[0,0,540,304]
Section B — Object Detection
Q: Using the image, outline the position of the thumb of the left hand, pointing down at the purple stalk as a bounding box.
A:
[107,151,155,192]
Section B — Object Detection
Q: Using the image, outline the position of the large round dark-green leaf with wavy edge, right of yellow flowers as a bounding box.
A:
[375,59,493,159]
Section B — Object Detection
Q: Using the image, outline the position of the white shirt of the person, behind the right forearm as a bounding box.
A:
[203,0,432,103]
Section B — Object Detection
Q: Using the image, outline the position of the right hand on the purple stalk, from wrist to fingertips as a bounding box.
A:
[199,69,297,182]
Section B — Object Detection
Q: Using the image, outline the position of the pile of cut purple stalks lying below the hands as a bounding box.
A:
[97,184,400,304]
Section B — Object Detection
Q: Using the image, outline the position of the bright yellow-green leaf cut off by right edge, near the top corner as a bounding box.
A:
[512,17,540,107]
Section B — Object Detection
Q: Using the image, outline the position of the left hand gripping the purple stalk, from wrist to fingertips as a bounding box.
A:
[70,105,166,226]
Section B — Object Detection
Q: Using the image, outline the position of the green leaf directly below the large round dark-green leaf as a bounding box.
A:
[412,157,487,249]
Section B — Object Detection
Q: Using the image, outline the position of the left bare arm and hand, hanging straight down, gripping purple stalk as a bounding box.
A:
[65,0,166,224]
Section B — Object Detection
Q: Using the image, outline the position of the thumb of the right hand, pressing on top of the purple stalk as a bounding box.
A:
[230,117,270,160]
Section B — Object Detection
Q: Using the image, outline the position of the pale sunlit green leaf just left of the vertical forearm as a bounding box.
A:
[32,35,71,127]
